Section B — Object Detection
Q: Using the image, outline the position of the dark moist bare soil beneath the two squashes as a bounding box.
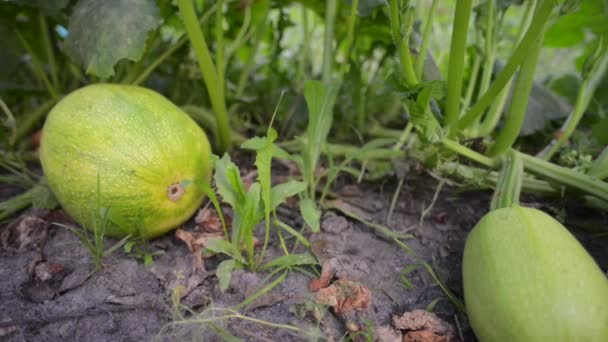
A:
[0,169,608,341]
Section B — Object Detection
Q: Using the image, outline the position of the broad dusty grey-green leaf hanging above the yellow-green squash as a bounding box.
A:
[66,0,160,78]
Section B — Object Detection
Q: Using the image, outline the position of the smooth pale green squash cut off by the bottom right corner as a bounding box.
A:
[463,207,608,342]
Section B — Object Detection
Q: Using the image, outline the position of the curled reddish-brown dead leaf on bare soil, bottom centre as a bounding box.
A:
[315,278,372,314]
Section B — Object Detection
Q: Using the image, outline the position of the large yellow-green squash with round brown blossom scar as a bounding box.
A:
[40,84,211,238]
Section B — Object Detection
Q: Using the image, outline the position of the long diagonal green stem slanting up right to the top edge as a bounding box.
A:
[458,0,557,129]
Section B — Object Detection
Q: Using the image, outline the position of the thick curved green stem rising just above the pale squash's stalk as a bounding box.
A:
[488,30,543,157]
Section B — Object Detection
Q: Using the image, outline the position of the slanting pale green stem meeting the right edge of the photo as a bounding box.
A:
[539,48,608,160]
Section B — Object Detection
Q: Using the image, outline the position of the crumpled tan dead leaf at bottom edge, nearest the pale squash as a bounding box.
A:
[393,310,455,342]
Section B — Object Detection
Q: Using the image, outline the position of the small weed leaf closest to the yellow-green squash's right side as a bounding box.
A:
[213,153,245,210]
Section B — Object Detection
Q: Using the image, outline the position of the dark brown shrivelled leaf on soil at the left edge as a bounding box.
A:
[0,215,51,252]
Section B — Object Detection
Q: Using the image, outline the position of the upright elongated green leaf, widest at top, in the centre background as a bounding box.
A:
[303,81,339,185]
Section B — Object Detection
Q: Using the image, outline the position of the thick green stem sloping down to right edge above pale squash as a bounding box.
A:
[516,152,608,201]
